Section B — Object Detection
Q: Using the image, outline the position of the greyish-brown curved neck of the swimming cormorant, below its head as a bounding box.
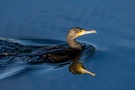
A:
[67,37,82,50]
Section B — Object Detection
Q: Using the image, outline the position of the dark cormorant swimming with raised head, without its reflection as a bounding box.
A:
[38,27,96,63]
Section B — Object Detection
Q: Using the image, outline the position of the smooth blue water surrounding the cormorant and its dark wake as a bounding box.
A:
[0,0,135,90]
